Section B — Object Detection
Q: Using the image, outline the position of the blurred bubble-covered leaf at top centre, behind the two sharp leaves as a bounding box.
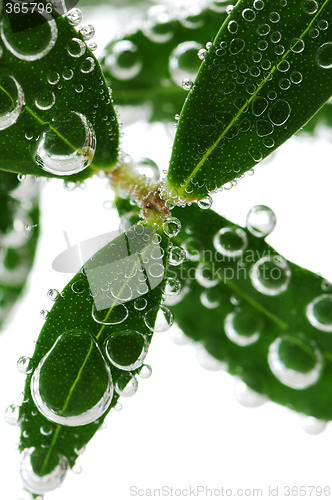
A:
[101,1,228,121]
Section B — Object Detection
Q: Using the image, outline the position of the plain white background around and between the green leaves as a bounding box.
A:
[0,3,332,500]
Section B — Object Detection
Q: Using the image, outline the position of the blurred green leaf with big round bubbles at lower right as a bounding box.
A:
[166,206,332,420]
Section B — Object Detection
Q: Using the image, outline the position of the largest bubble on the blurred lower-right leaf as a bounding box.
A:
[268,335,322,389]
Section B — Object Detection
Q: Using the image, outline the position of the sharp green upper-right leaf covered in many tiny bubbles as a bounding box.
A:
[168,0,332,203]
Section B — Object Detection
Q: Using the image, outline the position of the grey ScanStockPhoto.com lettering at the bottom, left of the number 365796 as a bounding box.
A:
[129,485,264,498]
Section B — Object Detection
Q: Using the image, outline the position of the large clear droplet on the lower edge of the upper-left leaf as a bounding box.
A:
[36,111,96,175]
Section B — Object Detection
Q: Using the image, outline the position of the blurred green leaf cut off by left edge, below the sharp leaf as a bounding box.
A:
[0,172,39,327]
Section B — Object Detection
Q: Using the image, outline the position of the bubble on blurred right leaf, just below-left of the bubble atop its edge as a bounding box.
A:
[213,227,248,257]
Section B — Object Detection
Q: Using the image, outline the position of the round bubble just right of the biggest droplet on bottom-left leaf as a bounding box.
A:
[105,330,148,371]
